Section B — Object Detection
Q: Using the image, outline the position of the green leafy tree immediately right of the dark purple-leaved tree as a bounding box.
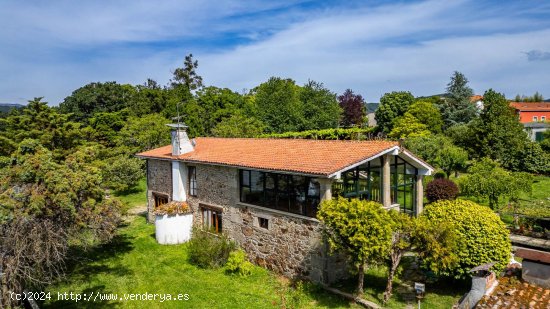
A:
[375,91,414,133]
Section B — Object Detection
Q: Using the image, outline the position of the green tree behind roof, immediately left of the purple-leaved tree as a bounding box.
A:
[300,80,342,130]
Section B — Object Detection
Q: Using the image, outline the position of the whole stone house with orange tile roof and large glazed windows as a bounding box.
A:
[137,125,433,282]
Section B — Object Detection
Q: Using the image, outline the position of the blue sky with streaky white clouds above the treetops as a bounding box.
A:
[0,0,550,105]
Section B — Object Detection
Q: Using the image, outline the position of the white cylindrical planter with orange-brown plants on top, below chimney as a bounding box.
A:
[154,201,193,244]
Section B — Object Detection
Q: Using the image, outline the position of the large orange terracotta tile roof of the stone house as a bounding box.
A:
[137,137,398,176]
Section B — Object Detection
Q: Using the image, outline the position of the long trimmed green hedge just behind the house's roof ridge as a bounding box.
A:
[259,127,375,140]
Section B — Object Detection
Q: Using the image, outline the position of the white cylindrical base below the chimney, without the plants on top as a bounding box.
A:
[155,213,193,245]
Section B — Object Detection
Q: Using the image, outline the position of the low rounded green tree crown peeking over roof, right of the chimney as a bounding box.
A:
[212,114,265,137]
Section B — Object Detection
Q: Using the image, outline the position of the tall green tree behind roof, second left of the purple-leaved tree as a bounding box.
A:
[253,77,304,133]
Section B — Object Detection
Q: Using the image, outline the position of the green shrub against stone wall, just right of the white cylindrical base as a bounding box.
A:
[187,228,237,268]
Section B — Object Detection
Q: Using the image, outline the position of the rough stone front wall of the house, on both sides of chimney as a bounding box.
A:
[149,163,347,283]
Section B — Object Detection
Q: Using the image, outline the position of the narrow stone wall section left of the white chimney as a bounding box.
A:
[147,159,172,223]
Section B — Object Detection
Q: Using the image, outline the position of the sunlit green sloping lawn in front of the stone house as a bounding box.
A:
[44,216,359,308]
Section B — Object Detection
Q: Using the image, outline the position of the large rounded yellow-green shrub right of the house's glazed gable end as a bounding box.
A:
[422,199,512,279]
